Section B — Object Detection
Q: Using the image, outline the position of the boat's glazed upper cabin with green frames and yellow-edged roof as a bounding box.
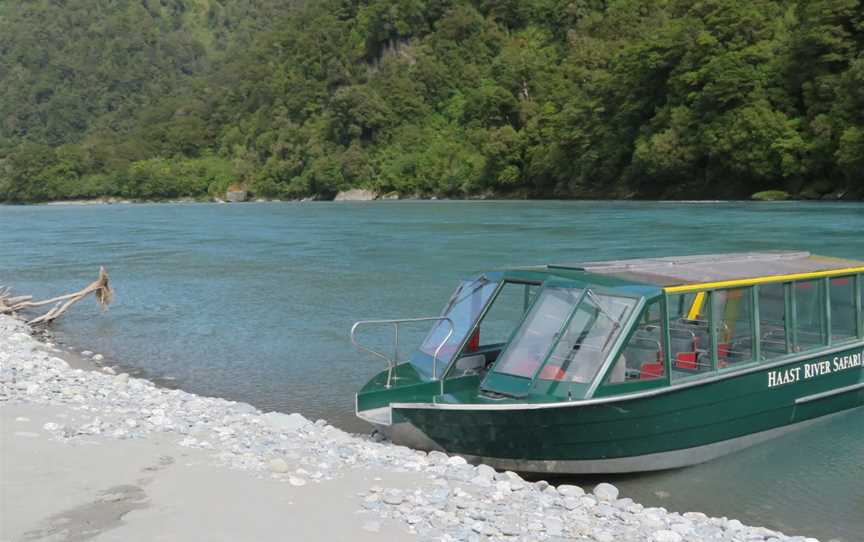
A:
[352,252,864,411]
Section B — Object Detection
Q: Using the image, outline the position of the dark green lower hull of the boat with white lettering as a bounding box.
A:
[379,344,864,473]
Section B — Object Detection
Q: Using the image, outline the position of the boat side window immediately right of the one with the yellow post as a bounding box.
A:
[711,288,754,369]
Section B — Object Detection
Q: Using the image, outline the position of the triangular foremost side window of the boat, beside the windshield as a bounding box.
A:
[606,301,666,384]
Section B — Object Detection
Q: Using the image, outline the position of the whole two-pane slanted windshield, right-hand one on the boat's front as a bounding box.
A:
[495,287,636,383]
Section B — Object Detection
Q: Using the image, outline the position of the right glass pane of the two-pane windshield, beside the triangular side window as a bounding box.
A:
[540,296,636,383]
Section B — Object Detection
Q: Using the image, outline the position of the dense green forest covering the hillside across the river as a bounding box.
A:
[0,0,864,202]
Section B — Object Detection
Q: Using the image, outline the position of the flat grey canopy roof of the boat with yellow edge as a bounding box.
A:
[547,251,864,292]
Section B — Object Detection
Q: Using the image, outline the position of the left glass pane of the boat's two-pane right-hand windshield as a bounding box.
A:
[495,287,582,378]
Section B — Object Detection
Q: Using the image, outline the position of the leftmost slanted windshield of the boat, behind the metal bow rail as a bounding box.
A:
[420,277,498,373]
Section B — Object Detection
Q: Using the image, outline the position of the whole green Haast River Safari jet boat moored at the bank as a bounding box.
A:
[351,252,864,473]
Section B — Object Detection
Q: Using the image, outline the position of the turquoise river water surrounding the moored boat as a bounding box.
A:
[0,201,864,541]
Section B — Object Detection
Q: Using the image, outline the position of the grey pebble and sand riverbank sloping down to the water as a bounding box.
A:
[0,316,813,542]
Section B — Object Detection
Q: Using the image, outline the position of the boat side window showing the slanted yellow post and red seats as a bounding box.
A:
[667,292,714,381]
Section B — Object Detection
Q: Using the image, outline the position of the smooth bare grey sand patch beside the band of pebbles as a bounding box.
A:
[0,404,416,542]
